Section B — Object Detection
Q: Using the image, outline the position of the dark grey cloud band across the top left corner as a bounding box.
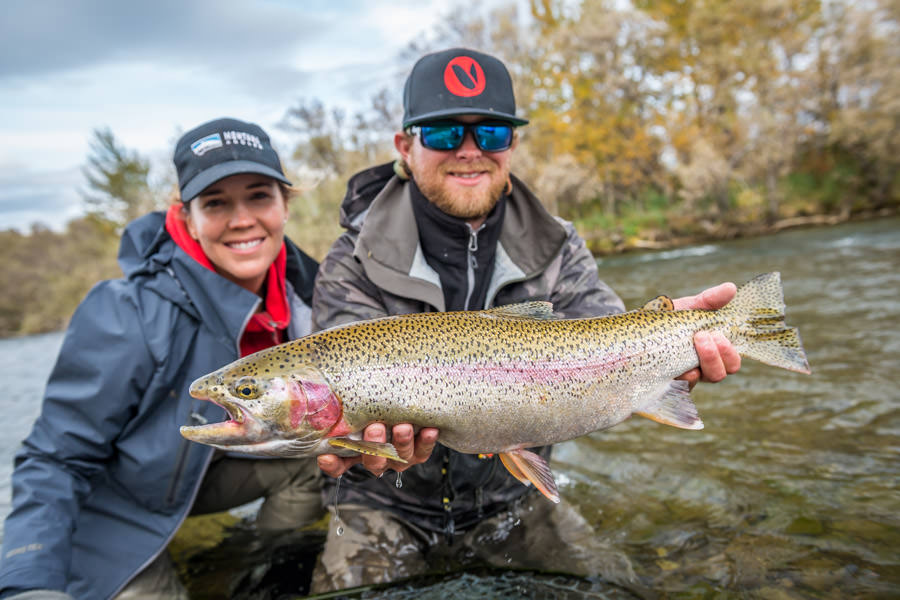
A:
[0,0,325,78]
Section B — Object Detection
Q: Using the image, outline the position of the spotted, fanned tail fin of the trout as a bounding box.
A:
[719,271,811,374]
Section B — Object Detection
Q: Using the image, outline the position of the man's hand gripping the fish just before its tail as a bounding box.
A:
[673,283,741,388]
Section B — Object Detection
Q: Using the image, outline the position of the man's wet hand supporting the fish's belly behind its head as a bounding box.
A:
[318,423,438,477]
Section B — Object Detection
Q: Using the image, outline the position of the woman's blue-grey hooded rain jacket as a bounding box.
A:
[0,213,317,600]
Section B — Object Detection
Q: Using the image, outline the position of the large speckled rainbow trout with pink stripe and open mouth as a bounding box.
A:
[181,273,810,502]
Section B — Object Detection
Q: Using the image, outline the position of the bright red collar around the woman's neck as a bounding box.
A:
[166,205,291,356]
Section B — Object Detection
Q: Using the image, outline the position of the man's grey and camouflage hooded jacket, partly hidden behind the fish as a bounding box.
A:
[313,164,624,534]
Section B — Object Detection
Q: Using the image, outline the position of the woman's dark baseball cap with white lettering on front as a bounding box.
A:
[174,118,291,202]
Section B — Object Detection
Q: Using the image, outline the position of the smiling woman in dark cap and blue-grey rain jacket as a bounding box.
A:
[0,119,322,600]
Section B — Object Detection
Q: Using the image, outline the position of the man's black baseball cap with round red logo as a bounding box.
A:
[403,48,528,129]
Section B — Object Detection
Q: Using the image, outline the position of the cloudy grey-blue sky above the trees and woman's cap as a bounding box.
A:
[0,0,478,232]
